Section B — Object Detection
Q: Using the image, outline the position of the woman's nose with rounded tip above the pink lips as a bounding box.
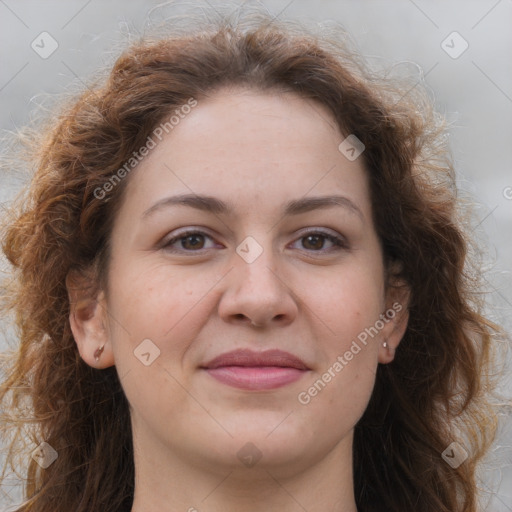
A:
[219,243,299,328]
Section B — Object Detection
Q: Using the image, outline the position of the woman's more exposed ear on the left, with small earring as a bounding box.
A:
[66,270,114,369]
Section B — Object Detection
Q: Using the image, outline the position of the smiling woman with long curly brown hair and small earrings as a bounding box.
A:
[0,7,502,512]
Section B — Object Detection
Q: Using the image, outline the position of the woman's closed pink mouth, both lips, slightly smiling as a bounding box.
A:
[201,350,310,391]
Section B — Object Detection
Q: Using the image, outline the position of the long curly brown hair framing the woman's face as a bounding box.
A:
[0,8,502,512]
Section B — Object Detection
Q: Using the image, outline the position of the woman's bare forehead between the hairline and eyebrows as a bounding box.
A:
[118,89,369,222]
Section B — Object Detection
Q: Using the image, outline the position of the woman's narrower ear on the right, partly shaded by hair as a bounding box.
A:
[379,268,411,364]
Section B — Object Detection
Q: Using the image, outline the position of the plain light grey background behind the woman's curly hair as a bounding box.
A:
[0,0,512,512]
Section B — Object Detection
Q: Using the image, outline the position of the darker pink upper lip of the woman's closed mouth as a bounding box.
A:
[202,349,309,370]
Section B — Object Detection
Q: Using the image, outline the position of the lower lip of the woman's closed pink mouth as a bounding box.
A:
[206,366,306,390]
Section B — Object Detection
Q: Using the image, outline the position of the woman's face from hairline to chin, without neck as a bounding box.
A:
[82,89,401,471]
